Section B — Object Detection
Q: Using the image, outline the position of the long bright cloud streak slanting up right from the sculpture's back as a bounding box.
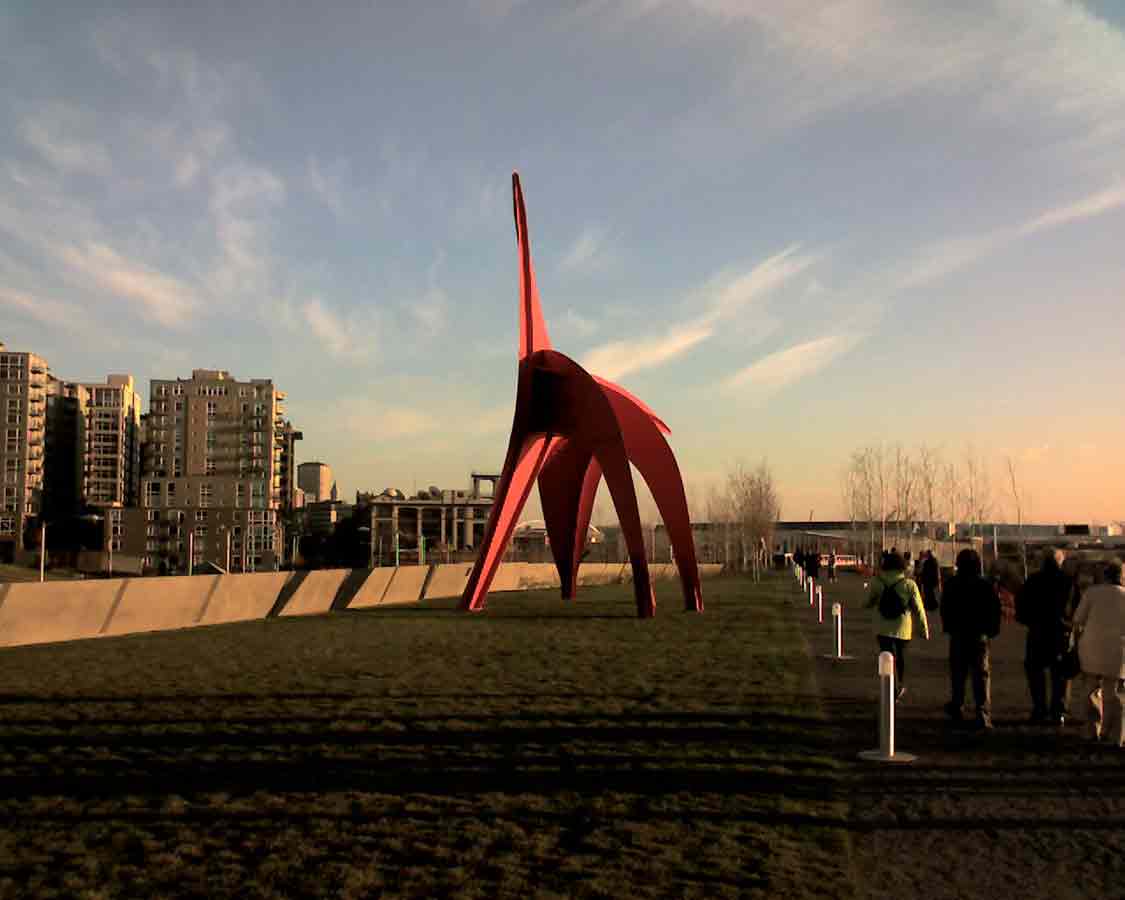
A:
[583,246,816,379]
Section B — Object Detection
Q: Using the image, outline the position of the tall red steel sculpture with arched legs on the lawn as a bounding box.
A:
[461,173,703,618]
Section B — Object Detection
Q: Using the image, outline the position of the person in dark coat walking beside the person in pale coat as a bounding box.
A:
[1016,548,1078,725]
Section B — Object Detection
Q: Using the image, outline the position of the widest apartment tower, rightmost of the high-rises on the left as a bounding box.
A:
[141,369,293,572]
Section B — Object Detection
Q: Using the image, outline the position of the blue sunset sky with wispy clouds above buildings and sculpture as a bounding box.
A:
[0,7,1125,520]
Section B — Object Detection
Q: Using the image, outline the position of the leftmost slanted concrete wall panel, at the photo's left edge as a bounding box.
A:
[0,578,127,647]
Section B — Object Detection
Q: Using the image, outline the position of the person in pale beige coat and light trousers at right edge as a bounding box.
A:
[1074,560,1125,747]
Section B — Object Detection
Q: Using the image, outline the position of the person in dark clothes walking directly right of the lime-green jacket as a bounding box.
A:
[942,550,1000,730]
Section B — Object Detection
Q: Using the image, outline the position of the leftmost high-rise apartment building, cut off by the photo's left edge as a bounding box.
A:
[0,343,47,561]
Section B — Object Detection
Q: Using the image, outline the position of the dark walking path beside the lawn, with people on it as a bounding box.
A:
[793,578,1125,900]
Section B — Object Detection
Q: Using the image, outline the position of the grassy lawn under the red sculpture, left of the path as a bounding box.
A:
[0,579,853,898]
